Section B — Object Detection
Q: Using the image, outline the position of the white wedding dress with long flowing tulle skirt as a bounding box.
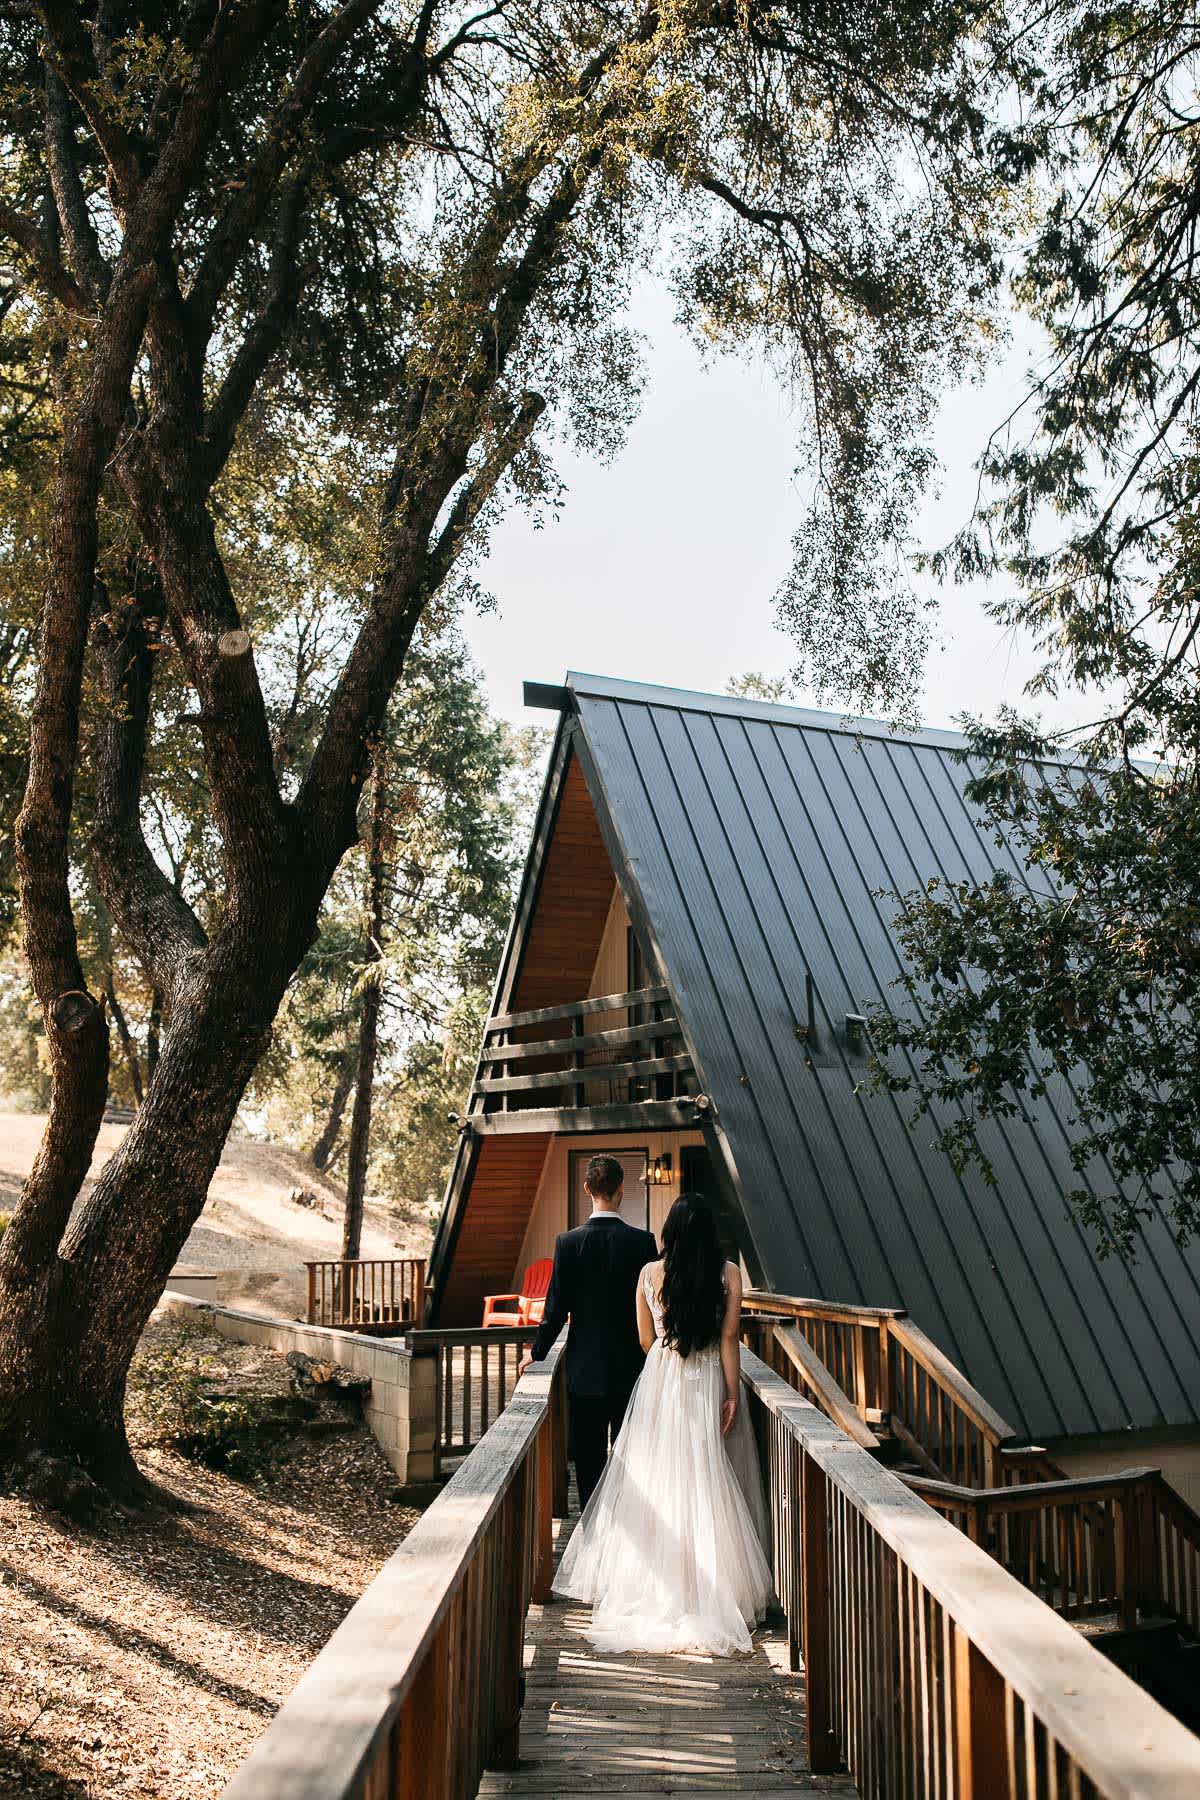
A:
[554,1267,772,1656]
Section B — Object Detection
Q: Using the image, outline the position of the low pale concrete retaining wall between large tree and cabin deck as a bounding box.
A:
[158,1287,435,1483]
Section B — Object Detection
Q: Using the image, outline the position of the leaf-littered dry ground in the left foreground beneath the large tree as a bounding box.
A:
[0,1321,416,1800]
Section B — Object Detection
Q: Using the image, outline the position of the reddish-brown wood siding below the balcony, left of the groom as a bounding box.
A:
[437,1132,551,1328]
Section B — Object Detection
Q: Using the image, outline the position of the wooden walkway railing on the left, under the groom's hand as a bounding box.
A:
[225,1341,567,1800]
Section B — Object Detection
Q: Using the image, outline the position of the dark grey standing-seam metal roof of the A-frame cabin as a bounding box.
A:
[567,675,1200,1436]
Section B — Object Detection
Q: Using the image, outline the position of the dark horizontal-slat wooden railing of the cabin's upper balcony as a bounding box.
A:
[471,988,693,1109]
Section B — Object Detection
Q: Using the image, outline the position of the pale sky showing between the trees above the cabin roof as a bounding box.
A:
[464,275,1096,725]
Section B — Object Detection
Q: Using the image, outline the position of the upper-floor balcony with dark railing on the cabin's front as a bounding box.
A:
[466,986,709,1132]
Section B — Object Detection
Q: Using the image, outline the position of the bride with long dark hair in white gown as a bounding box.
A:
[554,1193,772,1656]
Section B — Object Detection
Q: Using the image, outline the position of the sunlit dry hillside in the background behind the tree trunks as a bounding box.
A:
[0,1107,432,1318]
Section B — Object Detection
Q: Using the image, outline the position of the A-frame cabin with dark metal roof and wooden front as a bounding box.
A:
[430,675,1200,1499]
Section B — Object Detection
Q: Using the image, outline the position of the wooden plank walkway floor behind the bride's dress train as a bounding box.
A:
[479,1512,858,1800]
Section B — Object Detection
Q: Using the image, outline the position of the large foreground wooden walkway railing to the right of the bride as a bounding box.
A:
[741,1350,1200,1800]
